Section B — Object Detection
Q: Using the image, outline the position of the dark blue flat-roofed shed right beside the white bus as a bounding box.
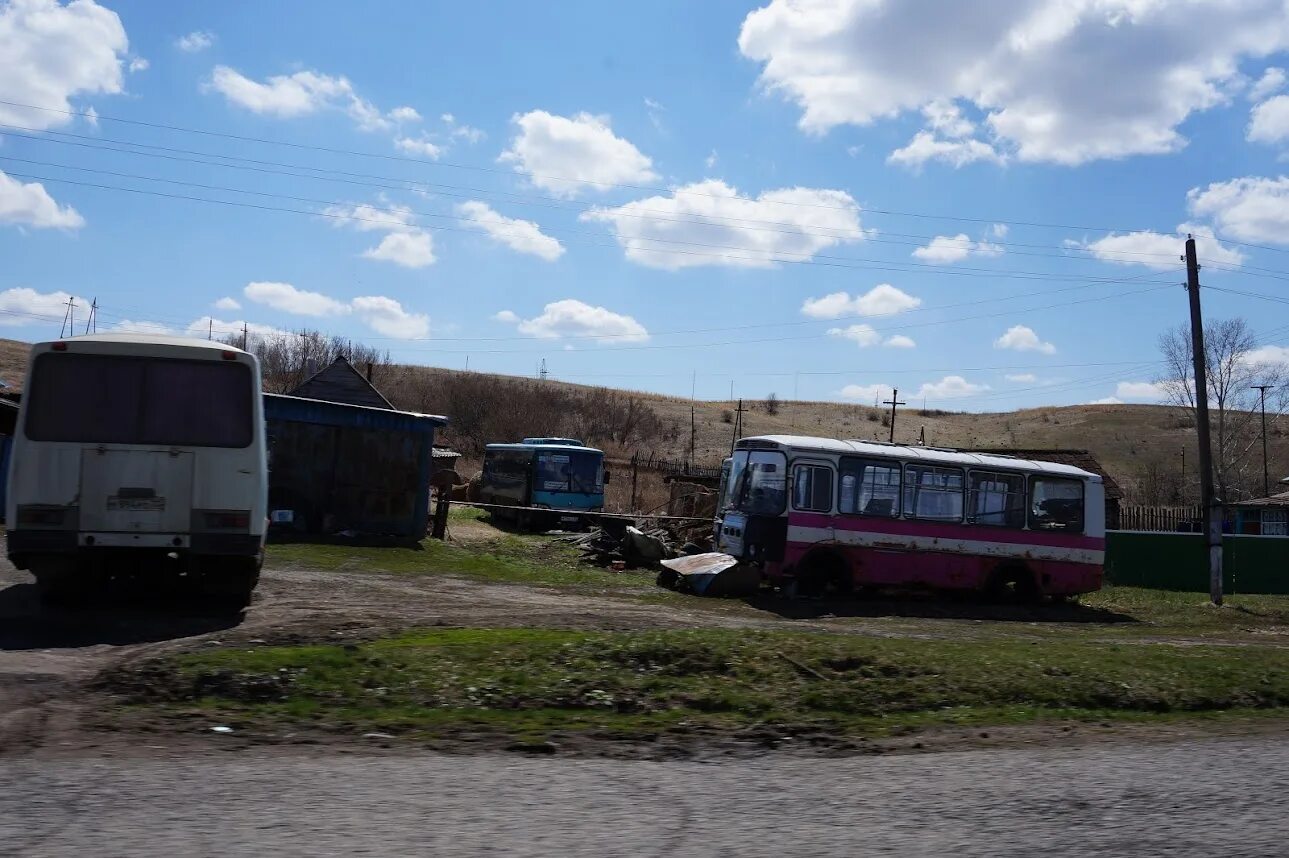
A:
[264,393,447,540]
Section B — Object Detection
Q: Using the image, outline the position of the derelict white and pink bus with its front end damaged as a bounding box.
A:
[715,435,1105,599]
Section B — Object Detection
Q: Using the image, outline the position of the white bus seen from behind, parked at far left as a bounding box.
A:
[5,334,267,603]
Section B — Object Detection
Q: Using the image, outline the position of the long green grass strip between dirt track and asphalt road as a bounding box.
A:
[113,620,1289,739]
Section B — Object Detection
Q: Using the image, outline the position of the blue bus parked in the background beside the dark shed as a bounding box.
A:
[480,438,608,527]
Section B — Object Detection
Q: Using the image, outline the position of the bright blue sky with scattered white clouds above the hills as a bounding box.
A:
[0,0,1289,411]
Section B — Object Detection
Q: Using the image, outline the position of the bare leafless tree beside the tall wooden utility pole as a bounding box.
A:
[1156,318,1289,501]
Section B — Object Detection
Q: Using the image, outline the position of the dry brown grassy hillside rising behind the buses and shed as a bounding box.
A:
[0,340,1289,502]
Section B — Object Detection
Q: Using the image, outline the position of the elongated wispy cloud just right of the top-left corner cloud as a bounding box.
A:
[209,66,415,131]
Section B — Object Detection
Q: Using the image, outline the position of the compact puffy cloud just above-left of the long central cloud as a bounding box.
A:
[498,111,657,197]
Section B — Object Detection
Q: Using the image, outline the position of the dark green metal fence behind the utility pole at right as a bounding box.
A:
[1106,531,1289,594]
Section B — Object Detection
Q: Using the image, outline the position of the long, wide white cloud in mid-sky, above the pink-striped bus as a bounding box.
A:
[581,179,865,271]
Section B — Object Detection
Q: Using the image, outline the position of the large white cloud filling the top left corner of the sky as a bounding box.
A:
[0,0,129,129]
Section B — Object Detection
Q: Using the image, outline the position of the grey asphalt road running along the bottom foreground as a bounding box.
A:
[0,737,1289,858]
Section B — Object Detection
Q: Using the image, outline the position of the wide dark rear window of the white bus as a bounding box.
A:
[24,354,255,447]
